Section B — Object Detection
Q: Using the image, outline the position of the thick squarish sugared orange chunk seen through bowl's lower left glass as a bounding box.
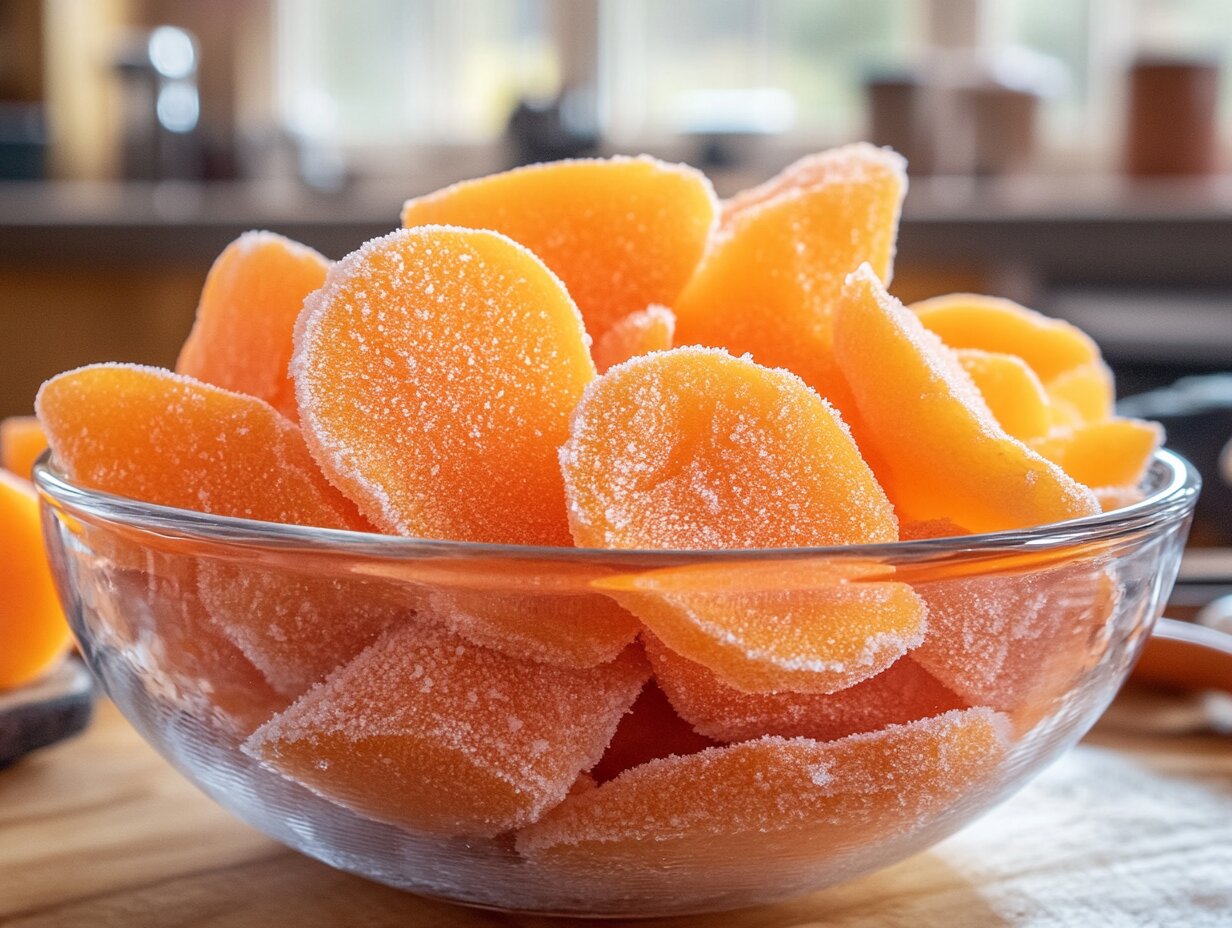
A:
[244,622,648,836]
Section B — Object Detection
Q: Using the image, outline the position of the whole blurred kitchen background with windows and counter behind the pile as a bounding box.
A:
[0,0,1232,564]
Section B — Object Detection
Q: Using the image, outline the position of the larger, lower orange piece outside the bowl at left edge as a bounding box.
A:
[0,470,70,690]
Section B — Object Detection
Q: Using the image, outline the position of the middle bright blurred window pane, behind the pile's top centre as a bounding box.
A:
[601,0,919,138]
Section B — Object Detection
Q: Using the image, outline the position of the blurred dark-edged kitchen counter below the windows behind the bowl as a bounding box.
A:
[0,174,1232,286]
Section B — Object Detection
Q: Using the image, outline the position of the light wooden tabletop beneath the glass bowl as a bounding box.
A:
[0,696,1232,928]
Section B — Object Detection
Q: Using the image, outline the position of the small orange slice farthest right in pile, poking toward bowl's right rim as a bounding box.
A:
[1031,419,1163,487]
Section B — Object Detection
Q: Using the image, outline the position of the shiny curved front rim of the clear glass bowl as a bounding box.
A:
[33,449,1201,564]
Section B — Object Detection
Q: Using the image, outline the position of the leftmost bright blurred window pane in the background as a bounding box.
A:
[275,0,559,147]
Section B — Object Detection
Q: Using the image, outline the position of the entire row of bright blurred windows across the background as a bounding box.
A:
[275,0,1232,161]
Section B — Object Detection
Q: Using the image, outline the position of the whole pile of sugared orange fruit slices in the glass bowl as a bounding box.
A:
[37,144,1162,873]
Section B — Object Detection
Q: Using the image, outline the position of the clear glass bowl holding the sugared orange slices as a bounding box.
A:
[36,452,1198,916]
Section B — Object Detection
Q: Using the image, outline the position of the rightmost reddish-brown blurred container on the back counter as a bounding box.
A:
[1125,55,1220,177]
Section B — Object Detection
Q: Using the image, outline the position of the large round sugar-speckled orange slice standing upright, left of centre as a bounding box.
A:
[292,226,595,545]
